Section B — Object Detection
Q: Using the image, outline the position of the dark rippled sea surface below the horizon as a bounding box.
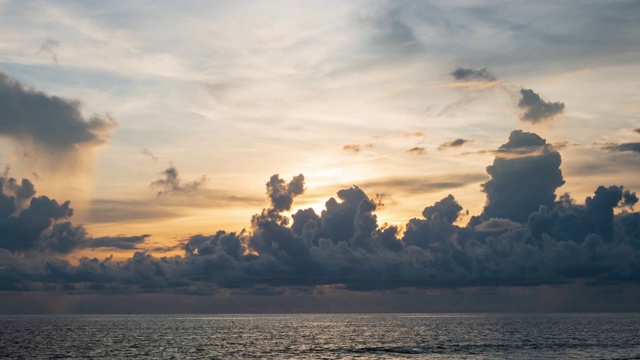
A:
[0,314,640,359]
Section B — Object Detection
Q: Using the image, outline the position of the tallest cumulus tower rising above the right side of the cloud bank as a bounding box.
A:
[481,130,564,222]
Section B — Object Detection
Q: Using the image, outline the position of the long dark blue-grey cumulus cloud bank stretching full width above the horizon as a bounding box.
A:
[0,130,640,294]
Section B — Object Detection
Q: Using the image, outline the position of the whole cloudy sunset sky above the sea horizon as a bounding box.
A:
[0,0,640,313]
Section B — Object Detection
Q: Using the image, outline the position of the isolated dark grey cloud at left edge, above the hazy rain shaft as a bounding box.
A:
[0,73,115,151]
